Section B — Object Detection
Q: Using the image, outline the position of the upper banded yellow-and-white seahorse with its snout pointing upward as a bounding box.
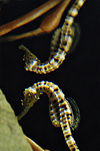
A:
[19,0,85,74]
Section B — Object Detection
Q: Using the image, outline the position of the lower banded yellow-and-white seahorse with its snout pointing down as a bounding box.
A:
[18,81,79,151]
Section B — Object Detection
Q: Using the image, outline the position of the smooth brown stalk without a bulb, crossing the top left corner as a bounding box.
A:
[0,0,62,36]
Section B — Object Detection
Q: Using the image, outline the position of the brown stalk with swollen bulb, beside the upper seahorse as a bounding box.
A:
[3,0,71,41]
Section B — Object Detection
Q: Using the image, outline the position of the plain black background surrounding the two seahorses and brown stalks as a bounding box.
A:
[0,0,100,151]
